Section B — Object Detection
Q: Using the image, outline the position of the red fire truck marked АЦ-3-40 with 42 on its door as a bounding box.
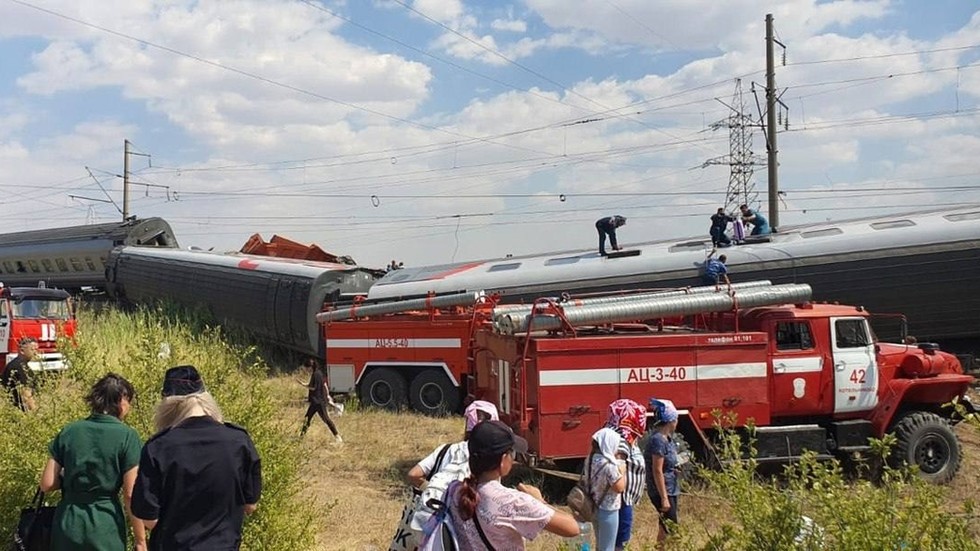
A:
[474,302,973,482]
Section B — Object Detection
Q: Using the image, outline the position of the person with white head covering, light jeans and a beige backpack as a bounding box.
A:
[586,427,626,551]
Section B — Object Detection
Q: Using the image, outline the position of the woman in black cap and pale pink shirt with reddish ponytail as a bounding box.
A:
[446,421,579,551]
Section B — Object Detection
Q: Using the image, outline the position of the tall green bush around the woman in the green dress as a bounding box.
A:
[0,309,314,551]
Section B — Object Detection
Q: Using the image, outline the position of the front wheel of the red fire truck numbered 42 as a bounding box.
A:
[892,411,962,484]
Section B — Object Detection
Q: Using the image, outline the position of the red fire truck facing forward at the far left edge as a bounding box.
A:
[0,287,75,371]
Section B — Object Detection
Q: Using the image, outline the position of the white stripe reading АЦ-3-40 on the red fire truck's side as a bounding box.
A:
[539,362,768,386]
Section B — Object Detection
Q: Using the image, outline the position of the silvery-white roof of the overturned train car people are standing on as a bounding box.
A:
[369,205,980,299]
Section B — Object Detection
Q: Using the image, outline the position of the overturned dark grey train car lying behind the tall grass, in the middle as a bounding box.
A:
[105,247,377,357]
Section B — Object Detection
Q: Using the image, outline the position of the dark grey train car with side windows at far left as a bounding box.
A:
[0,218,177,291]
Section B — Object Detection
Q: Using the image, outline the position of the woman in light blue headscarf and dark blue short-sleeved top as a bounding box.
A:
[643,400,681,543]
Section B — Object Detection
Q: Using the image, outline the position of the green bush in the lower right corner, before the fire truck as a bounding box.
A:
[675,418,980,551]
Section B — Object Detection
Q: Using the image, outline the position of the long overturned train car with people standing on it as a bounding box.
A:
[368,205,980,358]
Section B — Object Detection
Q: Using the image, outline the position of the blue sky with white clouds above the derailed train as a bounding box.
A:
[0,0,980,267]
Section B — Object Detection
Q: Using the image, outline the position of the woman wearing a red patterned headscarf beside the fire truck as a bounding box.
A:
[606,398,647,551]
